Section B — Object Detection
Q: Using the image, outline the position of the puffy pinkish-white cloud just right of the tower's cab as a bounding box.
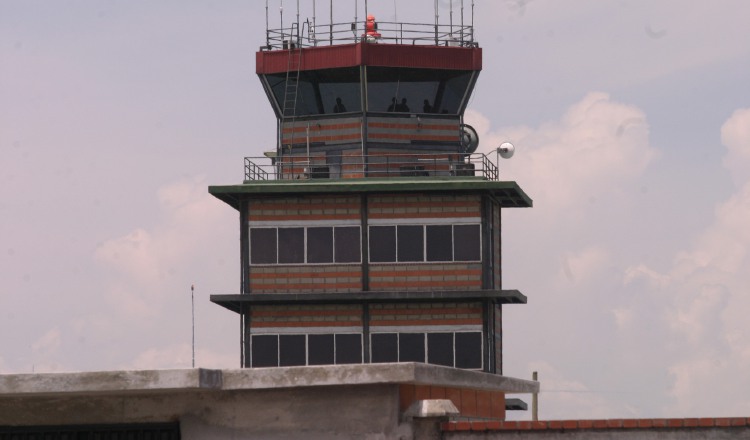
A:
[472,92,656,208]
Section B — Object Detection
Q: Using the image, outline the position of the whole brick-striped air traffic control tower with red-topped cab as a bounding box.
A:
[209,3,532,414]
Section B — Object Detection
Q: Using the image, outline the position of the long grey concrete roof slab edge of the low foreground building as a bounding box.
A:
[0,363,539,399]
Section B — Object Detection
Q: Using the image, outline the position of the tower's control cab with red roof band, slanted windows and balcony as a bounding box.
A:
[247,4,494,179]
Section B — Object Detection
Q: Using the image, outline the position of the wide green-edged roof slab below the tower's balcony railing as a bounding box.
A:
[208,177,533,209]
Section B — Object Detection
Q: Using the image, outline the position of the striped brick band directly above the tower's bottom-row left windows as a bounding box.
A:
[250,305,362,329]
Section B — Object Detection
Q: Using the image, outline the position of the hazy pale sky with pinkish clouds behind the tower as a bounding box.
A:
[0,0,750,419]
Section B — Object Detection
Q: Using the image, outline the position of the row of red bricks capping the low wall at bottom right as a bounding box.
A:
[441,414,750,432]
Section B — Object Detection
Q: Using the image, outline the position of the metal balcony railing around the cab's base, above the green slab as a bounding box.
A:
[245,153,498,181]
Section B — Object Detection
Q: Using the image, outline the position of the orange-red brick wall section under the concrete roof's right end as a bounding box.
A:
[399,385,505,422]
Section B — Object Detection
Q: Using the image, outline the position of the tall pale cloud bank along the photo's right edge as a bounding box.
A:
[625,109,750,415]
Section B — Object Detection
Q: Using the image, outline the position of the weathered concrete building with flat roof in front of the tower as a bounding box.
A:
[0,363,538,440]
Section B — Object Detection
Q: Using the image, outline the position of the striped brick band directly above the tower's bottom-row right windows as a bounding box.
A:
[370,303,482,332]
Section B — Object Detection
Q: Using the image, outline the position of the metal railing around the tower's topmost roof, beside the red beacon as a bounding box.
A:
[261,21,477,50]
